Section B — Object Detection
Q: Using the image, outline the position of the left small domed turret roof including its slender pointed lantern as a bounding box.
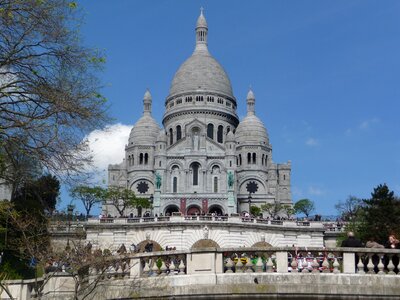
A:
[129,90,160,145]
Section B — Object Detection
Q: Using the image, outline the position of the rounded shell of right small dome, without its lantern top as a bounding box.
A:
[235,115,269,145]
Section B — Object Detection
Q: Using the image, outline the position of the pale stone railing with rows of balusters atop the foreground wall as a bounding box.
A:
[132,248,400,277]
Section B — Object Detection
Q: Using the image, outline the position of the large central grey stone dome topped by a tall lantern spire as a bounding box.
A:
[169,13,234,98]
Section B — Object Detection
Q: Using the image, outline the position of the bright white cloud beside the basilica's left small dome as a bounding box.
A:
[86,123,132,173]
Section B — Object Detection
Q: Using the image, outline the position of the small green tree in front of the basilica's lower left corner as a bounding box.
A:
[104,187,151,217]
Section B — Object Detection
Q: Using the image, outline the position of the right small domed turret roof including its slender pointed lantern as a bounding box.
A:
[235,89,269,144]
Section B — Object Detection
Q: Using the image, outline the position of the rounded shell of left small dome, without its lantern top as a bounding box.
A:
[129,114,160,145]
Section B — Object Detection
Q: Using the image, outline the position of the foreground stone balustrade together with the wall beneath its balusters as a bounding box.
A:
[0,247,400,300]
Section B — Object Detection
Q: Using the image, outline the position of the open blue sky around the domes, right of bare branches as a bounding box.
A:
[61,0,400,215]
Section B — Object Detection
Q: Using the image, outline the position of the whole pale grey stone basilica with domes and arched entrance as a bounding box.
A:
[103,12,292,215]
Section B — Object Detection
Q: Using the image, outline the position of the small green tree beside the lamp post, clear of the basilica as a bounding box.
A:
[70,185,106,217]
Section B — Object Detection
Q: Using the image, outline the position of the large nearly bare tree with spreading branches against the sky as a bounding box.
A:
[0,0,109,184]
